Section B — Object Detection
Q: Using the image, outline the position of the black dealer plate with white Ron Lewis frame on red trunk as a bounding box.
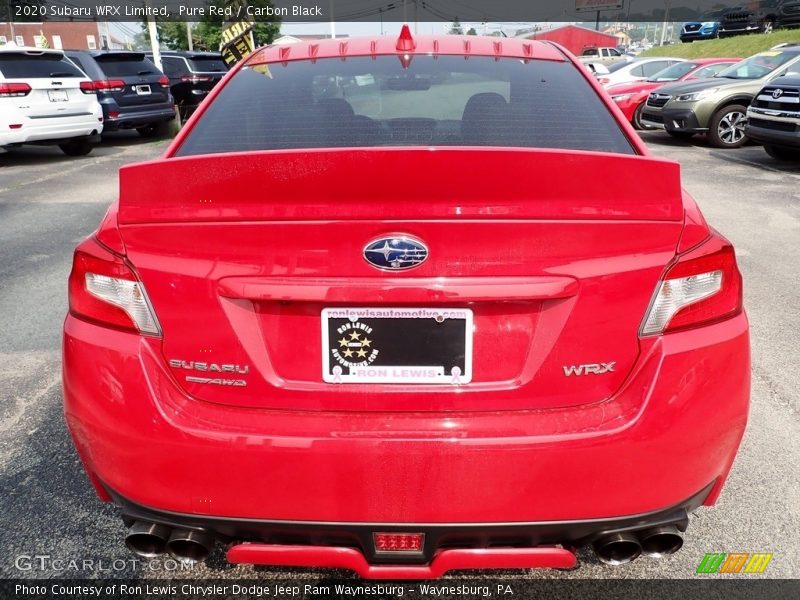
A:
[321,307,472,385]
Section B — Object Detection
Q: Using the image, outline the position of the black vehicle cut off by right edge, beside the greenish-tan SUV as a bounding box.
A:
[745,73,800,160]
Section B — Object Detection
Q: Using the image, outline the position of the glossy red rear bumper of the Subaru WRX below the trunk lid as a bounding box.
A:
[63,314,750,524]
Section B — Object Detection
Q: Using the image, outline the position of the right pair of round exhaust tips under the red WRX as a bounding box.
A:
[592,525,683,565]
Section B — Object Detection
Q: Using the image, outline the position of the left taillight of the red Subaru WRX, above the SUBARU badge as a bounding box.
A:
[69,237,161,335]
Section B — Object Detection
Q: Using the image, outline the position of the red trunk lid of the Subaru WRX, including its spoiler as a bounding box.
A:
[119,148,683,411]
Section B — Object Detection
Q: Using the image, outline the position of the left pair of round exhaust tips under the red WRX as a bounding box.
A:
[125,521,214,563]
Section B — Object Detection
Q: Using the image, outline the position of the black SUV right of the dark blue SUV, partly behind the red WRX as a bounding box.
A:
[148,51,228,119]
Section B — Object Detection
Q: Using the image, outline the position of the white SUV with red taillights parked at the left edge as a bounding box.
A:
[0,46,103,156]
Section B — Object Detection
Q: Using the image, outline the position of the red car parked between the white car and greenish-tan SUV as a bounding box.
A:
[606,58,742,129]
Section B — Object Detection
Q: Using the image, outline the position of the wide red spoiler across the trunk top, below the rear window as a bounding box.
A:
[119,148,683,225]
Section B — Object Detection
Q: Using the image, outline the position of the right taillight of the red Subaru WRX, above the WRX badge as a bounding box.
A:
[641,235,742,335]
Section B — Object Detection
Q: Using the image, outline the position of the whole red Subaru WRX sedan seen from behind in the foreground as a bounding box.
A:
[64,28,749,579]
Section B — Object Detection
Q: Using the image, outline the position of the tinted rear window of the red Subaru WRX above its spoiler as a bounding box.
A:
[177,55,634,157]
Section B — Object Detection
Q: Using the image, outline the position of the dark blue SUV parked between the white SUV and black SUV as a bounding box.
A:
[64,50,175,137]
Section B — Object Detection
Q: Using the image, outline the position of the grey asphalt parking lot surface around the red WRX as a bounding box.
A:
[0,132,800,579]
